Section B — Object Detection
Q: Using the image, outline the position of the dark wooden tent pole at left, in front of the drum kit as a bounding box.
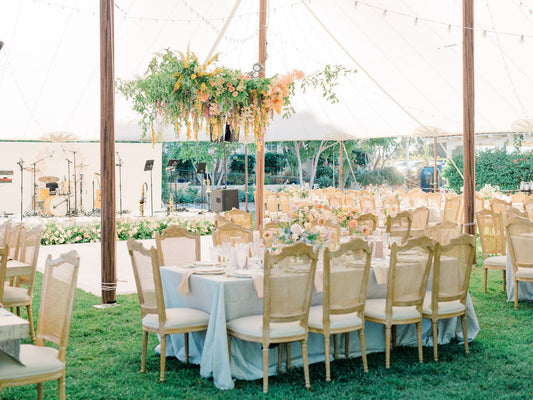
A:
[100,0,117,304]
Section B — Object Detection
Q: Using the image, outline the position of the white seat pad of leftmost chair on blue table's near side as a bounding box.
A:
[226,315,306,339]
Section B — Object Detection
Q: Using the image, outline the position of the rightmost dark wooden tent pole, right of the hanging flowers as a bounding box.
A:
[463,0,476,235]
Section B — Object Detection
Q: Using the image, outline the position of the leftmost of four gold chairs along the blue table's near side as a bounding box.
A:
[226,242,317,393]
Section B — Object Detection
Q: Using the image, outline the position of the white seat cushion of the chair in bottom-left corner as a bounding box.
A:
[0,344,65,381]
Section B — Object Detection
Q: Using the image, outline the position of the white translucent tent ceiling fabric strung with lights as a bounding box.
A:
[0,0,533,140]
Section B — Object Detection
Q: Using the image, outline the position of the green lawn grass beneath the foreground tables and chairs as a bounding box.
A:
[2,267,533,400]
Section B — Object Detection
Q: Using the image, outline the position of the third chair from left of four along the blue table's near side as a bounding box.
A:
[365,237,434,368]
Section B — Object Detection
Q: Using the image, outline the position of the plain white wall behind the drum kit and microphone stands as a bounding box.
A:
[0,142,161,215]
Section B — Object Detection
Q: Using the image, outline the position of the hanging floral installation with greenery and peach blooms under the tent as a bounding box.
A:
[117,50,355,141]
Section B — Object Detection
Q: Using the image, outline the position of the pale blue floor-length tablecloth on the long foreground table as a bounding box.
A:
[156,266,479,389]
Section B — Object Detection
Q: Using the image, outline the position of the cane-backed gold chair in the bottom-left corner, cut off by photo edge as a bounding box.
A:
[0,251,79,400]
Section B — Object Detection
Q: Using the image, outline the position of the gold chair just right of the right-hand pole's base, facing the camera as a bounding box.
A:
[476,209,504,293]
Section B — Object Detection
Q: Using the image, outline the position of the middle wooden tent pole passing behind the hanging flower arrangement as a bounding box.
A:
[255,0,267,229]
